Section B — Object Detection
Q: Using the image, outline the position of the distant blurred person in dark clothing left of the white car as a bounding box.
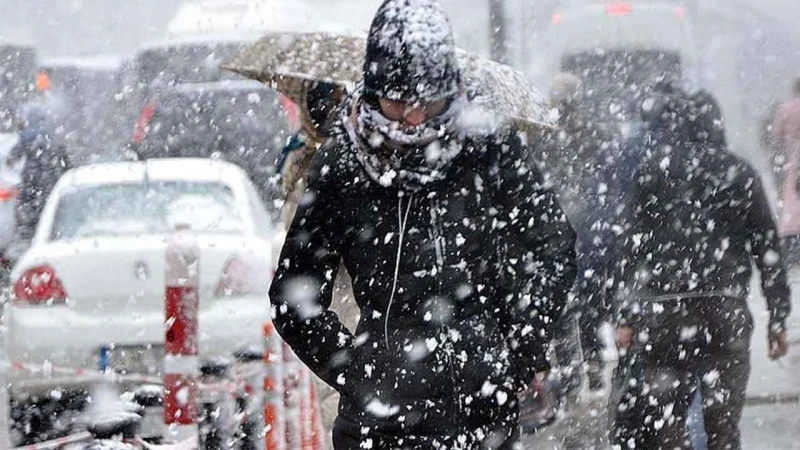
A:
[9,104,69,242]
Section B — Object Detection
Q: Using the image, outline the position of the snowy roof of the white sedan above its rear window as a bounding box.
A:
[59,158,245,186]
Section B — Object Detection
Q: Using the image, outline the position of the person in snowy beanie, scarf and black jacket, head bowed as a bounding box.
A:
[270,0,575,450]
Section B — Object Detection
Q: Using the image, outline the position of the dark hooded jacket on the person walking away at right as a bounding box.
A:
[618,89,790,329]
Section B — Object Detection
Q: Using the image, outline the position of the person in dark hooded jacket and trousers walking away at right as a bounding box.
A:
[611,88,791,450]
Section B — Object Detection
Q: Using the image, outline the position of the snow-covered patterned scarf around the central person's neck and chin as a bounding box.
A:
[342,89,464,191]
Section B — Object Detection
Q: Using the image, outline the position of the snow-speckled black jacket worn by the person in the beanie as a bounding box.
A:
[270,114,575,442]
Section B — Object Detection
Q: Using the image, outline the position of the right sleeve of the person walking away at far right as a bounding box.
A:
[747,173,791,331]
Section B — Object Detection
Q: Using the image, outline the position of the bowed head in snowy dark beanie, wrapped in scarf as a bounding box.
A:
[349,0,465,190]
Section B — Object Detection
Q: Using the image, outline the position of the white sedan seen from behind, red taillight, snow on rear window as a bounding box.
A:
[6,158,276,385]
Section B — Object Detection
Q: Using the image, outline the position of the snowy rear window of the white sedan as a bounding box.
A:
[50,181,244,241]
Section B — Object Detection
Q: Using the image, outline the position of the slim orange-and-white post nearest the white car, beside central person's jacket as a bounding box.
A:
[264,321,286,450]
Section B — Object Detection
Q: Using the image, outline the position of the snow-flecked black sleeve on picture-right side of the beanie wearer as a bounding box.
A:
[495,136,576,386]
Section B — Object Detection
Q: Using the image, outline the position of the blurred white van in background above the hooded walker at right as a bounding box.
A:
[531,2,698,134]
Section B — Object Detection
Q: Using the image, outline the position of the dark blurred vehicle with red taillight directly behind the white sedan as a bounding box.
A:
[132,81,289,214]
